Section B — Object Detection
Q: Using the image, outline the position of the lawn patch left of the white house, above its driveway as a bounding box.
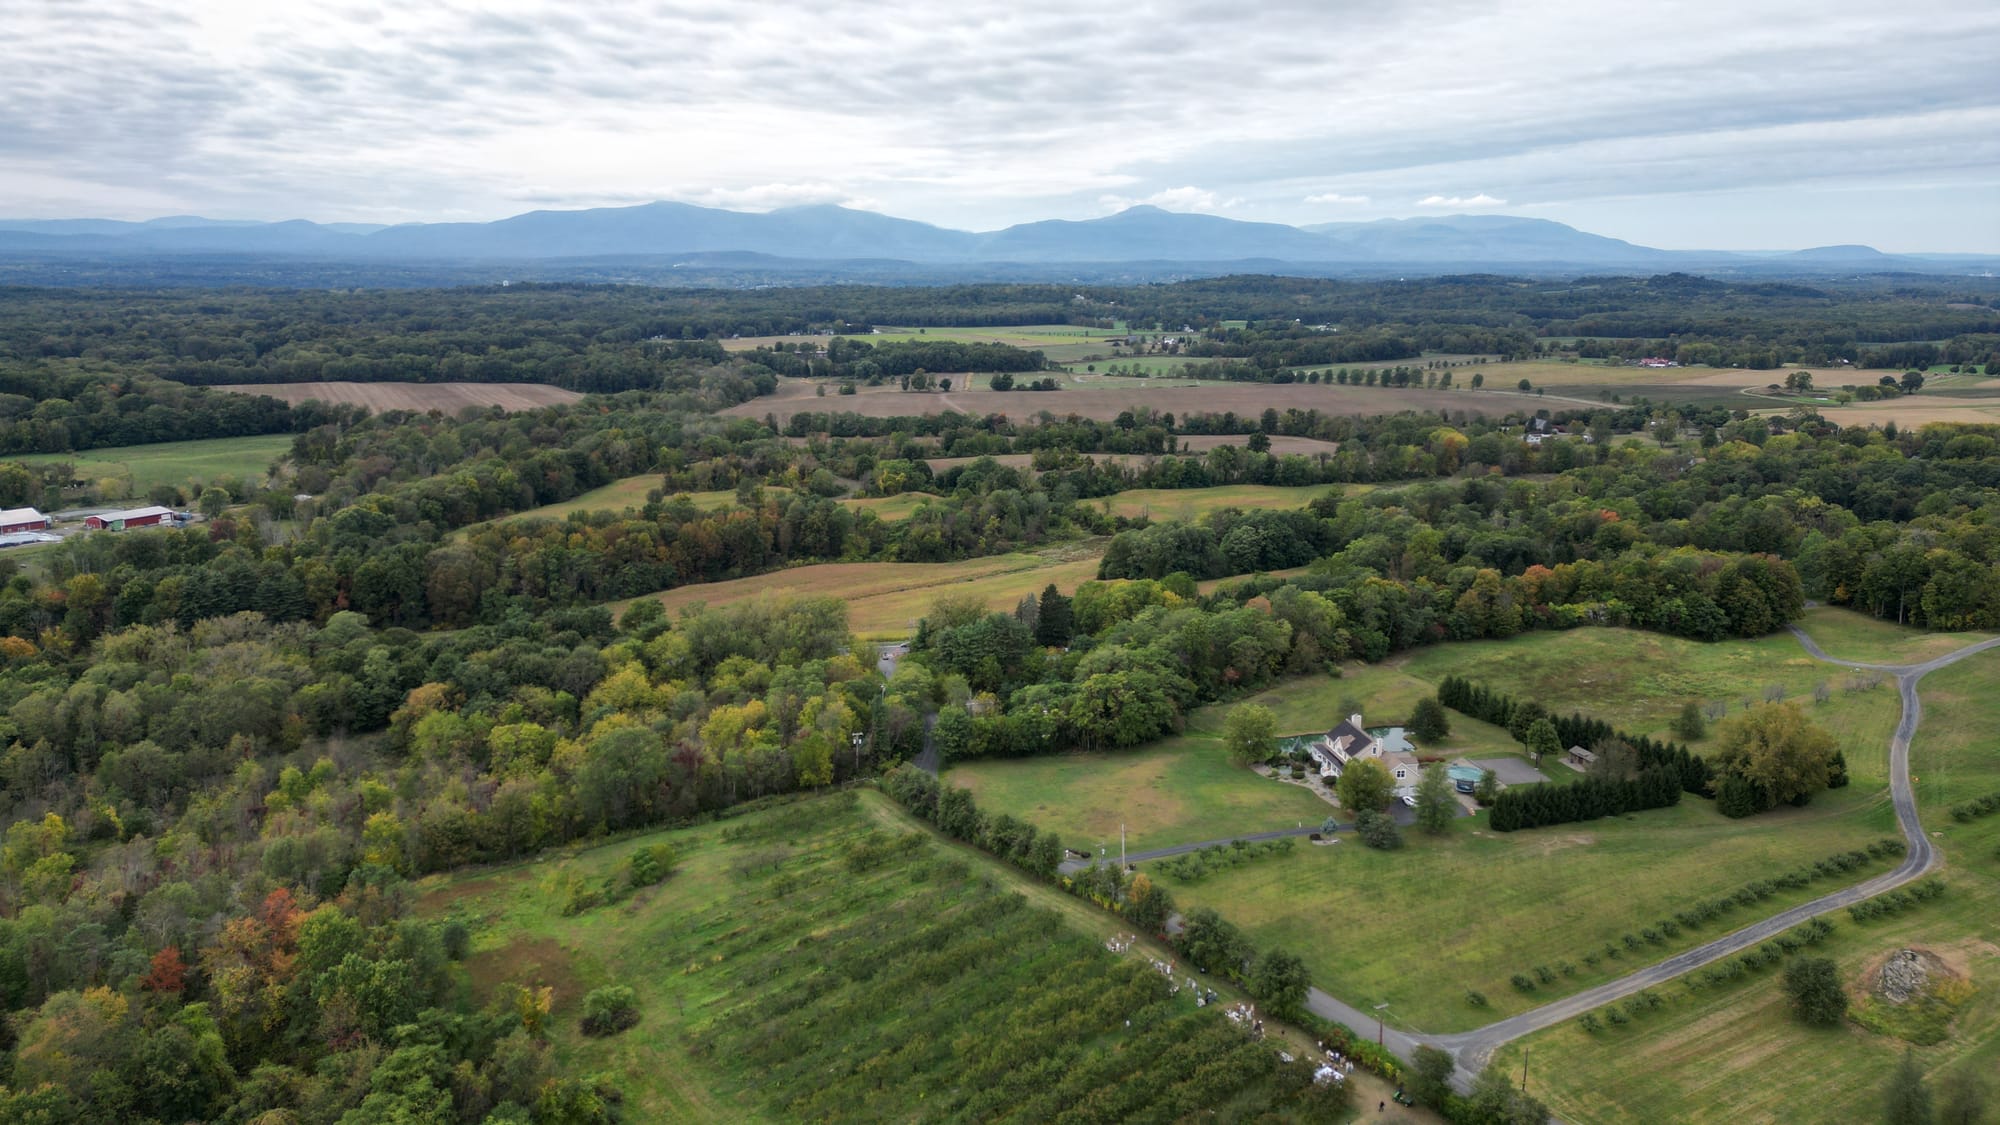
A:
[944,735,1334,851]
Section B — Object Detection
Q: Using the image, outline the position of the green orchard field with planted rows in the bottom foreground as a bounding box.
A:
[420,791,1418,1121]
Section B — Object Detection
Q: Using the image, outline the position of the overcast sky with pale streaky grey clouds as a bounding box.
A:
[0,0,2000,252]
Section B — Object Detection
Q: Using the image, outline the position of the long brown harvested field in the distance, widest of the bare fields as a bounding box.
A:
[724,378,1496,426]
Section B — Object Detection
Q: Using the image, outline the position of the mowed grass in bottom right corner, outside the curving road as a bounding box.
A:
[1494,653,2000,1125]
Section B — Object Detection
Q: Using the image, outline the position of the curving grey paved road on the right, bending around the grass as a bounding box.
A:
[1408,625,2000,1087]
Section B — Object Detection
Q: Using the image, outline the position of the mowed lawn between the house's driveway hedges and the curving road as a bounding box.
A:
[1154,789,1890,1033]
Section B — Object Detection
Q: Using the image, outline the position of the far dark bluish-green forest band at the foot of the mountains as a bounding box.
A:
[0,274,2000,406]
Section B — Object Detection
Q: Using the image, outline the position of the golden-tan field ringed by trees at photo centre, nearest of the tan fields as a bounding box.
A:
[614,540,1104,641]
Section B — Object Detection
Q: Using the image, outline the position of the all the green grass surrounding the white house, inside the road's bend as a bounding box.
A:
[950,629,1898,1033]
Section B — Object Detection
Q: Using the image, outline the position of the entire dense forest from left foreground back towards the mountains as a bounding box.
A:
[0,278,2000,1123]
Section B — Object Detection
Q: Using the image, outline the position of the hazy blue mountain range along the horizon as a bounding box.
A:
[0,202,2000,274]
